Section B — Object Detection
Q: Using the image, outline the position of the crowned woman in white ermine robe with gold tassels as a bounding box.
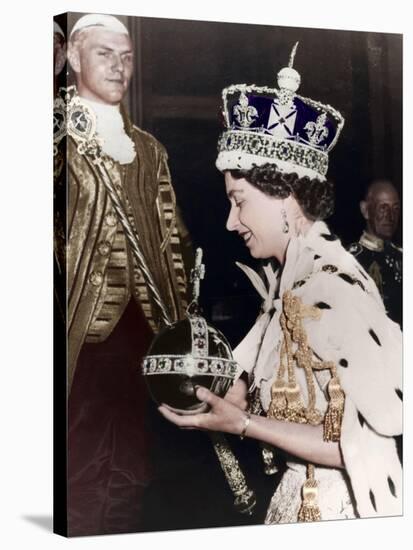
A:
[159,44,402,523]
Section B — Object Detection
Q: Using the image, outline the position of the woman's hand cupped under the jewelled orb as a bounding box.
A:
[158,387,245,435]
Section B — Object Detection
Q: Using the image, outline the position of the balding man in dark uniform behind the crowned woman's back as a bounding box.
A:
[349,180,403,326]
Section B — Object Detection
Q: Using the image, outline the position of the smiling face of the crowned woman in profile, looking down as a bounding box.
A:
[225,172,295,263]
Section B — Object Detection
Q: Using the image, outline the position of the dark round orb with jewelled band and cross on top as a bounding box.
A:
[142,249,237,413]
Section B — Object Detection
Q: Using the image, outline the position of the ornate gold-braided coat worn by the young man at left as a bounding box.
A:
[67,108,186,387]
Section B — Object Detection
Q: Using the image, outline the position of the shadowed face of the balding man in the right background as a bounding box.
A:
[366,184,400,240]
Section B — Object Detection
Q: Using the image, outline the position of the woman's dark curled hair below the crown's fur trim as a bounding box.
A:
[230,163,334,220]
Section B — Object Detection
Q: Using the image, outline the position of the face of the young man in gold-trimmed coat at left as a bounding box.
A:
[70,28,133,105]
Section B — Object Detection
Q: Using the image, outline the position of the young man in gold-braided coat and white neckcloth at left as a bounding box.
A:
[59,14,186,535]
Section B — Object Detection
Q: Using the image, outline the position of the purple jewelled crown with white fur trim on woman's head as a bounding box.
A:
[216,42,344,180]
